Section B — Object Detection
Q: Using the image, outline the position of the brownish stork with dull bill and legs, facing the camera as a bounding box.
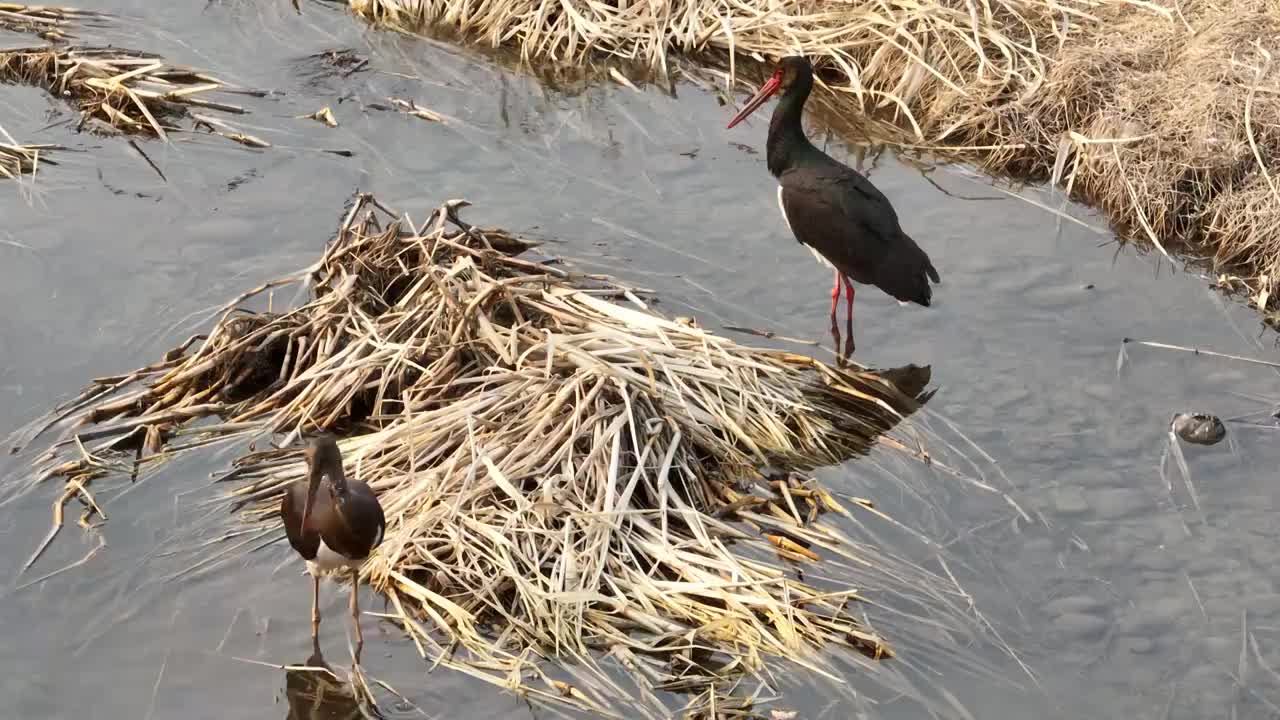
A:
[280,436,387,655]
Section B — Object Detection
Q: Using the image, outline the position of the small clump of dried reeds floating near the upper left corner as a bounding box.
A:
[0,46,266,146]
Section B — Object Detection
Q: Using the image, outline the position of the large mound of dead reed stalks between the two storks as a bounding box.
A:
[15,195,1003,717]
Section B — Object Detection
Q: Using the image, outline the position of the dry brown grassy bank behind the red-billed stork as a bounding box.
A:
[349,0,1280,309]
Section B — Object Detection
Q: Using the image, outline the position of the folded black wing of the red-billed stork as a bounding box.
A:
[778,158,938,305]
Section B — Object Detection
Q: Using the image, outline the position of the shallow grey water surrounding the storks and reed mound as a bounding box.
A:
[0,0,1280,719]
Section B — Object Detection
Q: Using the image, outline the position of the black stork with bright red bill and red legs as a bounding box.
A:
[728,56,941,356]
